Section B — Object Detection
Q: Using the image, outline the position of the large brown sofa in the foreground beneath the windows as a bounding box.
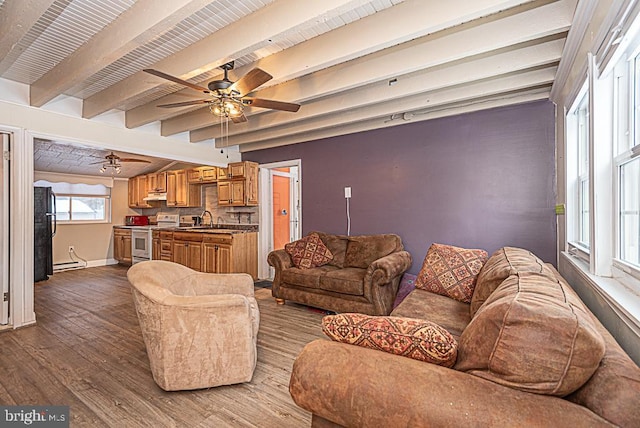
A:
[290,248,640,427]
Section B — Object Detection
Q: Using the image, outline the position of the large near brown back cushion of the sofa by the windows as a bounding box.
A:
[456,272,605,397]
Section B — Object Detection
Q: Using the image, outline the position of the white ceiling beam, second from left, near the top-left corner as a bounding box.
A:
[30,0,216,107]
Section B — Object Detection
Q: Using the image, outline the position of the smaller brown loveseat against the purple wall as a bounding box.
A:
[268,232,411,315]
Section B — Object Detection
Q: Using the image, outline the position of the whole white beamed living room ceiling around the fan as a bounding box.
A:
[0,0,577,157]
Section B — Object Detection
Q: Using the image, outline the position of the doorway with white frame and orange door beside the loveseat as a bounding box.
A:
[258,159,302,279]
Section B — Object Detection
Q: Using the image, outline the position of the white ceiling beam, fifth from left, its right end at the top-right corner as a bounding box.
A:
[175,2,571,136]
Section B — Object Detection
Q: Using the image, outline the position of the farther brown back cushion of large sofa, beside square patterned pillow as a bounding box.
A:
[469,247,555,317]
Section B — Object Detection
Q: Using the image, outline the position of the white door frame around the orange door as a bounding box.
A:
[258,159,302,279]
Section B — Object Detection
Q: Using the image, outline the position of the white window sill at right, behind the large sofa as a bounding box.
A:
[562,252,640,336]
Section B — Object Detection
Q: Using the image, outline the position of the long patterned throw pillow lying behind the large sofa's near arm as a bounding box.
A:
[322,313,458,367]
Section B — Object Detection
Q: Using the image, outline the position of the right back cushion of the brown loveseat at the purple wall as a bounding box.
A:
[344,234,402,269]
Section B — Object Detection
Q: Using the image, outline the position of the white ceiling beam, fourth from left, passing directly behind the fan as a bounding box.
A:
[126,0,531,128]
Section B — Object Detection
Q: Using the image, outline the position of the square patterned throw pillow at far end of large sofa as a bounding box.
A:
[416,244,489,303]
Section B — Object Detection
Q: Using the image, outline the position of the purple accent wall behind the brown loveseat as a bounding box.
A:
[243,101,556,274]
